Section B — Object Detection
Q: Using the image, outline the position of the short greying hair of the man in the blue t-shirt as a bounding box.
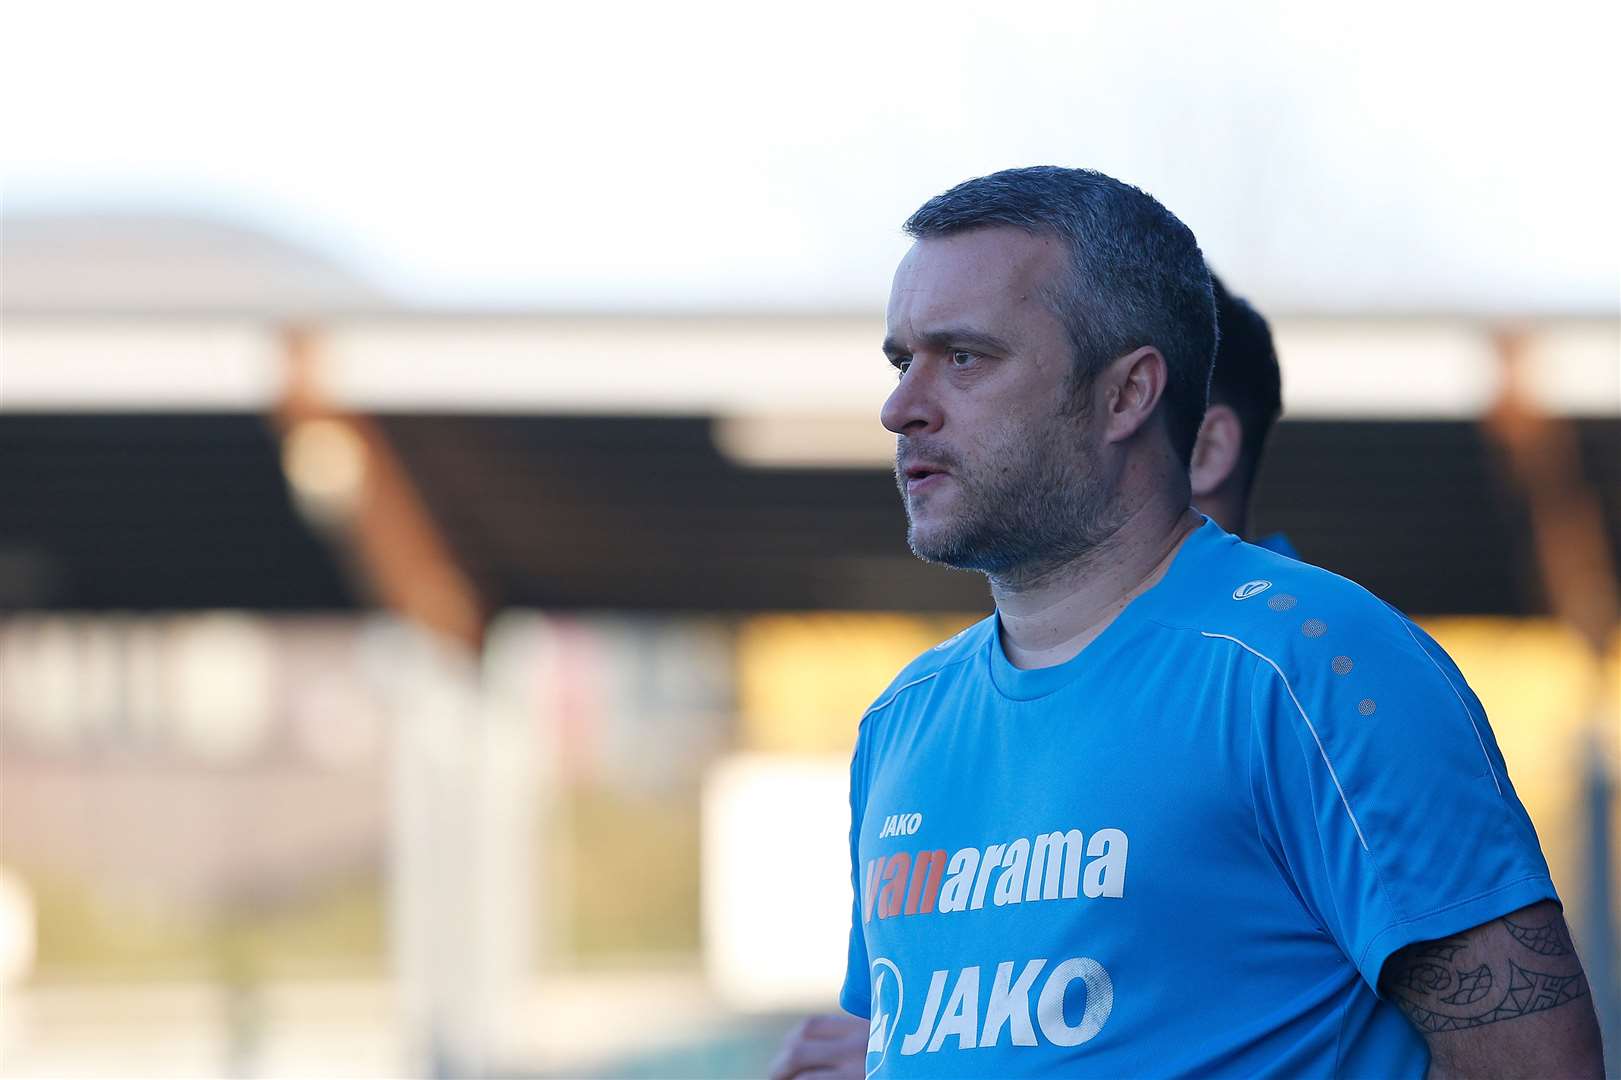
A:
[905,165,1216,467]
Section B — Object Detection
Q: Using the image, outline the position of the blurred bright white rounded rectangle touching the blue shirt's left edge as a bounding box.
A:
[702,754,853,1012]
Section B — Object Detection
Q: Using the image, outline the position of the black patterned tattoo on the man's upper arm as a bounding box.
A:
[1381,913,1587,1033]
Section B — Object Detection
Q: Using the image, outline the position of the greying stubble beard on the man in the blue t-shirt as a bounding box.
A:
[895,431,1118,582]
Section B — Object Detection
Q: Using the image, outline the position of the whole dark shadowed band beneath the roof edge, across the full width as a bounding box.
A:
[0,414,1621,615]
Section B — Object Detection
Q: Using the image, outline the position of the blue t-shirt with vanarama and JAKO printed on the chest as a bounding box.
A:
[840,521,1555,1077]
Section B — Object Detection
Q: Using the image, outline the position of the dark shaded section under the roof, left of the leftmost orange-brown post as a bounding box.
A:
[0,414,355,611]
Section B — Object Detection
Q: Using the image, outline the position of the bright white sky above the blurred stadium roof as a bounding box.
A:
[0,0,1621,313]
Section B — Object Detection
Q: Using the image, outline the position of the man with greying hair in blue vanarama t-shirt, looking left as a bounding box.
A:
[776,167,1602,1077]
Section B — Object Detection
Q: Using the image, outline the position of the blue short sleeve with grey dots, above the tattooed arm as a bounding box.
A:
[1250,611,1558,991]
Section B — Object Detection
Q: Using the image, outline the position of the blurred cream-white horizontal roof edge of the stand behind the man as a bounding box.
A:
[0,310,1621,418]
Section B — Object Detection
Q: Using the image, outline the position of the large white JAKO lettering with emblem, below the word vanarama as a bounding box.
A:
[867,957,1114,1057]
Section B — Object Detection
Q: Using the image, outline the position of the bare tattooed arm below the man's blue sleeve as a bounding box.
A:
[1379,900,1605,1080]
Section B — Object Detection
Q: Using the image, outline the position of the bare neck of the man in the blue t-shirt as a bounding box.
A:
[990,506,1200,670]
